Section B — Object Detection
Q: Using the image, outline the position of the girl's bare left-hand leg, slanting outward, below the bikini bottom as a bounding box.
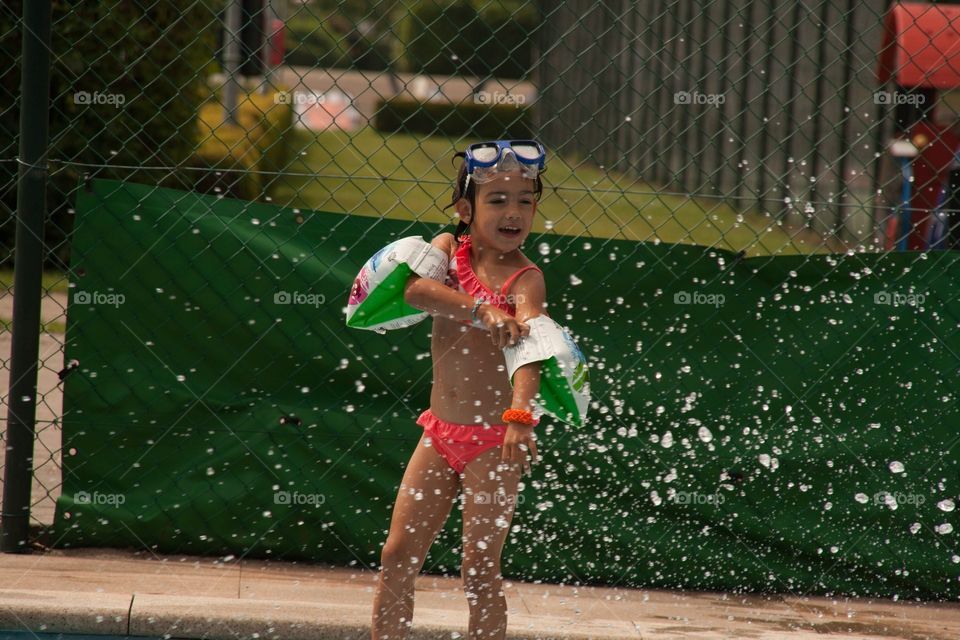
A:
[371,433,460,640]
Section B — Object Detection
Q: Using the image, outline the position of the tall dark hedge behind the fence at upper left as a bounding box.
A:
[0,0,219,267]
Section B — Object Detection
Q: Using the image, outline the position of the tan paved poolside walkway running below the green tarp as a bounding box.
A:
[0,549,960,640]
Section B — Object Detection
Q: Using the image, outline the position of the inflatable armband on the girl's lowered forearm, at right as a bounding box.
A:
[503,315,590,427]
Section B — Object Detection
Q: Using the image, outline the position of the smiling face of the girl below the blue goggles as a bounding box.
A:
[457,171,537,253]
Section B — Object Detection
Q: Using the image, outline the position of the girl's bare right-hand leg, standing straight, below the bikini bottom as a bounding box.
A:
[461,447,522,640]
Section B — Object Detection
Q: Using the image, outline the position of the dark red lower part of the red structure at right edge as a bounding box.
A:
[907,121,960,251]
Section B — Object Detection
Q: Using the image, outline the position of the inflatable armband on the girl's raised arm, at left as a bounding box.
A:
[347,236,450,333]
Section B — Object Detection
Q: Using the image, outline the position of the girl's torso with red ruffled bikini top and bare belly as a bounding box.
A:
[430,237,536,424]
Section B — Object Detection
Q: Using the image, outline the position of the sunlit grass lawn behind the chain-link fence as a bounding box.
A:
[273,127,826,255]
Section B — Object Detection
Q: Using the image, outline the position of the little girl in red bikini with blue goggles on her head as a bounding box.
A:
[371,140,546,640]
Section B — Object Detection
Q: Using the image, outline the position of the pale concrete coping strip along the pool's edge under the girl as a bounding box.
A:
[0,588,640,640]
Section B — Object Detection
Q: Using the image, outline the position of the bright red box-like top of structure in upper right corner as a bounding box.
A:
[877,2,960,89]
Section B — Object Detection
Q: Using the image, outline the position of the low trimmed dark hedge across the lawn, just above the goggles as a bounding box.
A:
[374,98,533,139]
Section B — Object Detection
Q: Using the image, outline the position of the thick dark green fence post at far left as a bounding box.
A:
[0,0,52,553]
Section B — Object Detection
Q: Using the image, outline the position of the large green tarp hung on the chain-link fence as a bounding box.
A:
[56,180,960,599]
